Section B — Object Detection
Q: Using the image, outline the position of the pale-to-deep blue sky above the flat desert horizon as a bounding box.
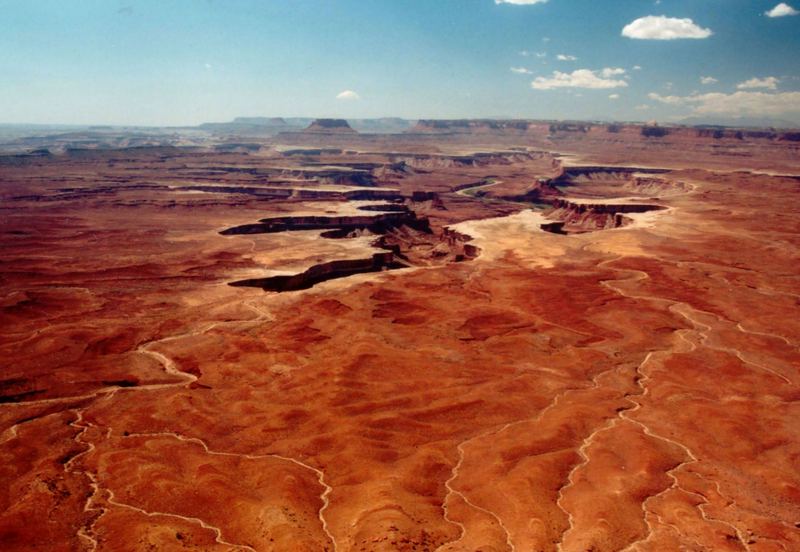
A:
[0,0,800,125]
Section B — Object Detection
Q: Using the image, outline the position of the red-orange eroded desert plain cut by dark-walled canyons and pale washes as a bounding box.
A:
[0,120,800,552]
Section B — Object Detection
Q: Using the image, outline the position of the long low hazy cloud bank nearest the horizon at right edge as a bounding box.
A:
[648,91,800,117]
